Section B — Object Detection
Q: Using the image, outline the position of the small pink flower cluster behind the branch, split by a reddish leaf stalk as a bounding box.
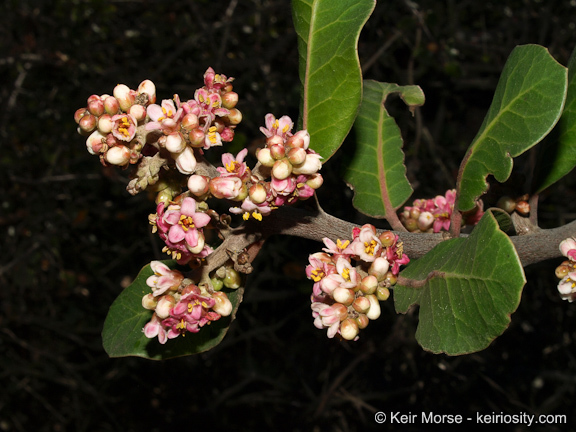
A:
[400,189,484,233]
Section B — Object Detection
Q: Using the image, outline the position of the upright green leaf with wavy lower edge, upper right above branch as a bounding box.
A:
[457,45,567,211]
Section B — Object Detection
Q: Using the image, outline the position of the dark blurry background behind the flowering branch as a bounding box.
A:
[0,0,576,431]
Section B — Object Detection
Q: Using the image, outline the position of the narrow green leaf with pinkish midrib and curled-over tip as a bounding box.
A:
[344,81,424,218]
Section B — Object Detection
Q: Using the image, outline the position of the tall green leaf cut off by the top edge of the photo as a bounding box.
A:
[292,0,376,161]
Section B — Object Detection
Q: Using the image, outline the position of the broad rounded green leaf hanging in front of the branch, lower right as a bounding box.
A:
[394,212,526,355]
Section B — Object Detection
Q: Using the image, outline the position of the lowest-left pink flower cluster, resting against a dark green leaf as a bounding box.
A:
[142,261,232,344]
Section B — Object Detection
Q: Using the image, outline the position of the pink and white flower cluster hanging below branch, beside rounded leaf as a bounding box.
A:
[306,224,410,340]
